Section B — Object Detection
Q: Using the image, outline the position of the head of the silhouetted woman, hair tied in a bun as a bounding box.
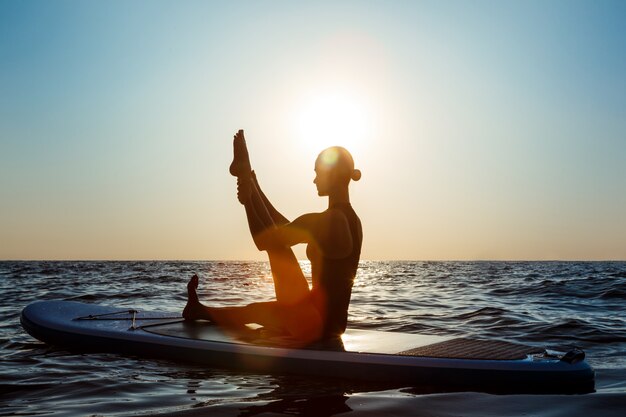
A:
[313,146,361,195]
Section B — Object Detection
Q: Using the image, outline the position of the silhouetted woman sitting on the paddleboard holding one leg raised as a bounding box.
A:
[183,130,363,345]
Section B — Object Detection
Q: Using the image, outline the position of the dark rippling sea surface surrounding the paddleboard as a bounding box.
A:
[0,261,626,417]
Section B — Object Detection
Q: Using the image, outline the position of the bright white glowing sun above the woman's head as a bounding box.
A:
[294,90,373,156]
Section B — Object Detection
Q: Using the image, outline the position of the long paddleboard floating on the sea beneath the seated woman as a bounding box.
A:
[21,301,594,393]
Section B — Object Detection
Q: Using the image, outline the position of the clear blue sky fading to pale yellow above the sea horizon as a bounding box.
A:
[0,0,626,260]
